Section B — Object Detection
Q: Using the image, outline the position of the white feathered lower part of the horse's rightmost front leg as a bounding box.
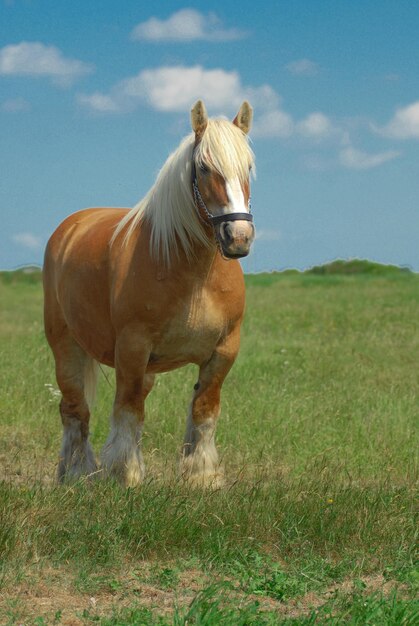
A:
[181,411,224,488]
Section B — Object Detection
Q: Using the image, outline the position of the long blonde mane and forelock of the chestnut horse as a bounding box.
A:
[111,119,254,265]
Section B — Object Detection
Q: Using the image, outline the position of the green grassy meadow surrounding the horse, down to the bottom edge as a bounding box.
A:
[0,262,419,626]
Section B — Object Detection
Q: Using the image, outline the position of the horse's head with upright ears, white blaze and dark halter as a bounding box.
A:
[191,100,255,259]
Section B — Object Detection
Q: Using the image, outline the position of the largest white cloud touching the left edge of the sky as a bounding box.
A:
[0,41,93,85]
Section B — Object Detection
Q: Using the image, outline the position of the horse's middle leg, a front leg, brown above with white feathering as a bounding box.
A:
[101,333,154,487]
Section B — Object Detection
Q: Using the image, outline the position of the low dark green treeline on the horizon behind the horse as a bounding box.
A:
[0,259,413,284]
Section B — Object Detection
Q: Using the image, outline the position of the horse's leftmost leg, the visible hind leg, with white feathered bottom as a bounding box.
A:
[52,331,97,482]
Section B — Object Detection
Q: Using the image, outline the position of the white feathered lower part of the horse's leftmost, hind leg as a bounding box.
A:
[58,417,97,482]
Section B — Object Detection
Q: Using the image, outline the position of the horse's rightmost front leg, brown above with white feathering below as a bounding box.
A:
[181,325,240,487]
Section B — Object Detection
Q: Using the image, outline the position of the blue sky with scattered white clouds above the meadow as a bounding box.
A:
[0,0,419,272]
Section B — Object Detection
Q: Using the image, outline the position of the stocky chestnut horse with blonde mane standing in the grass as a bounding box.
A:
[43,100,255,487]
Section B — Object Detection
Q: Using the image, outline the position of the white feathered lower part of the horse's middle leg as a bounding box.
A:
[102,411,145,487]
